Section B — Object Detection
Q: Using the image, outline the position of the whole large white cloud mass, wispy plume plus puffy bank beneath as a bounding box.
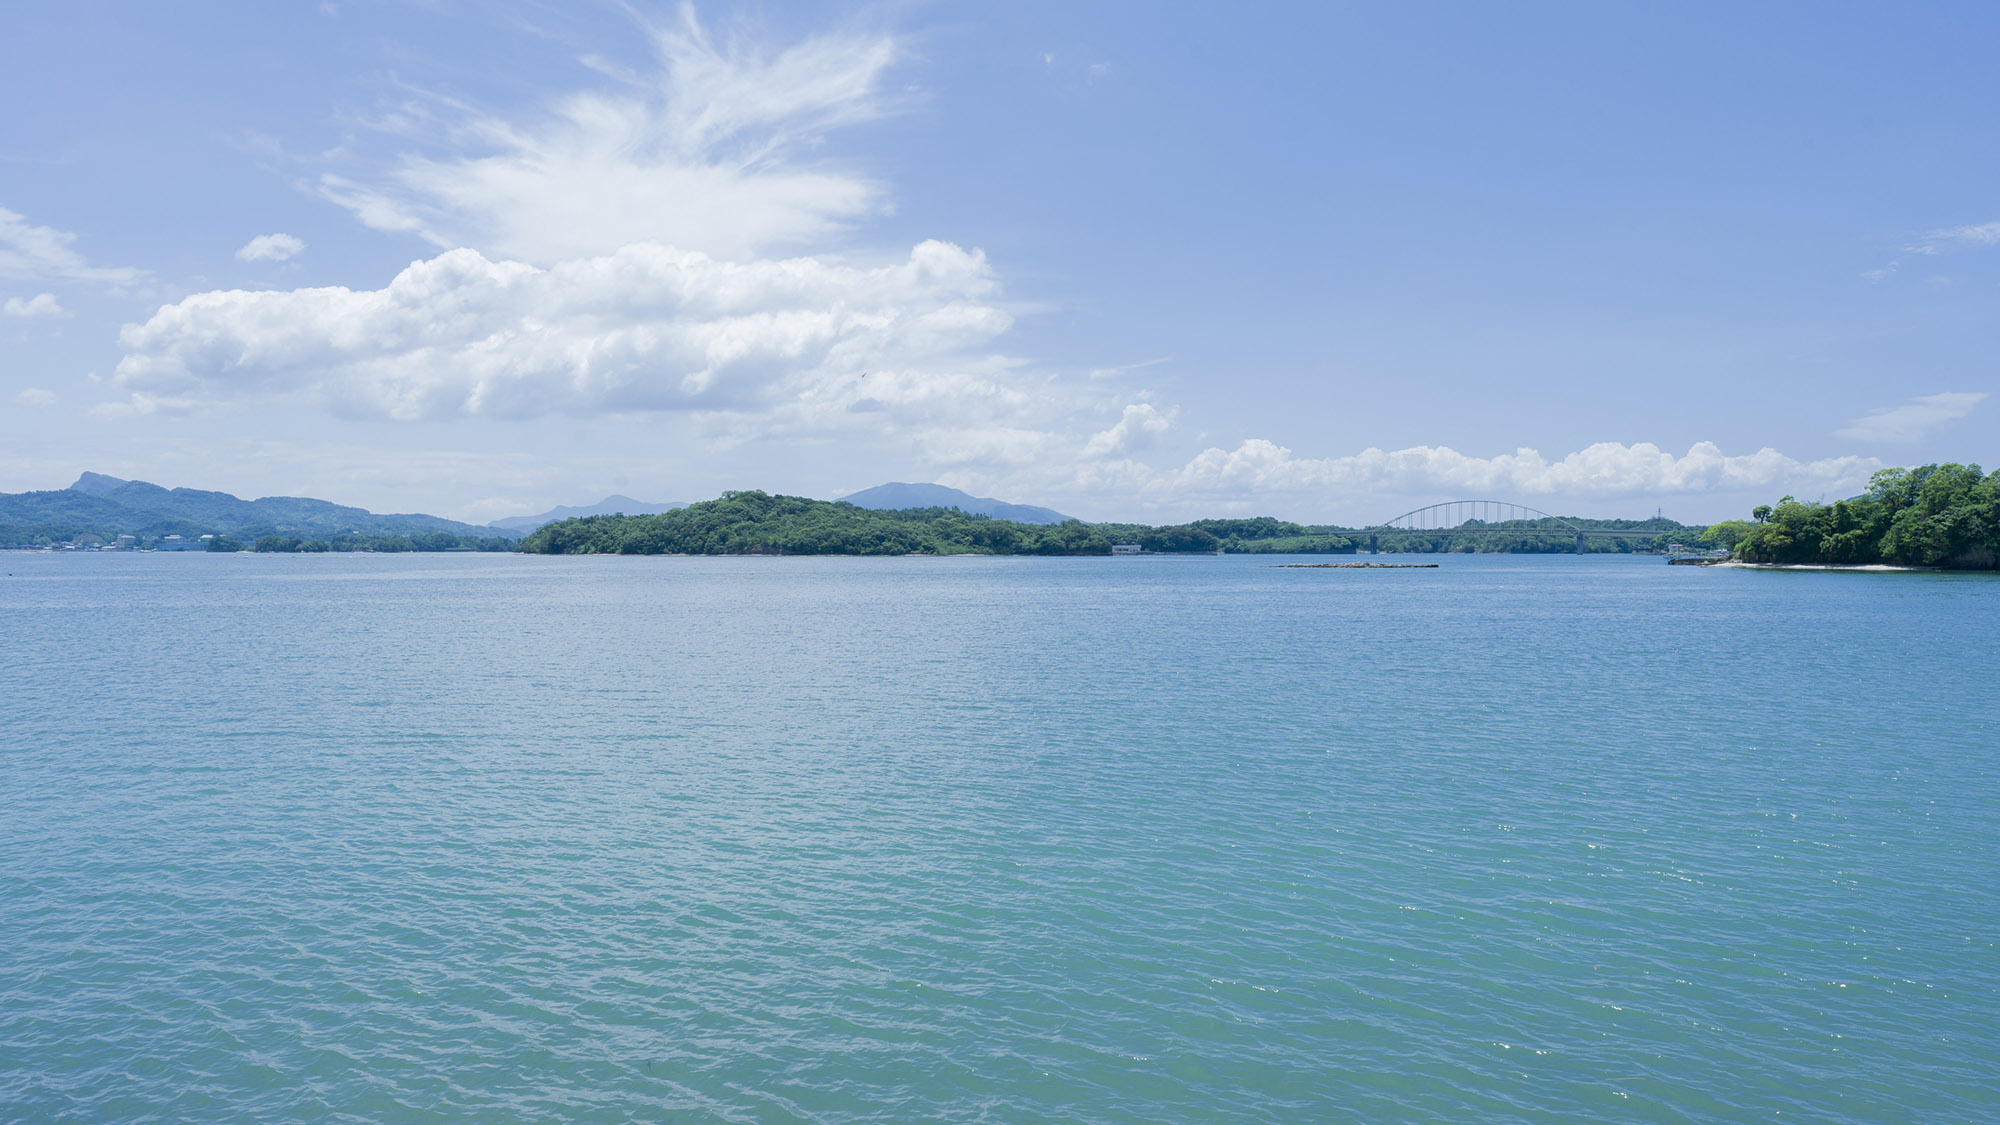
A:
[117,10,1096,450]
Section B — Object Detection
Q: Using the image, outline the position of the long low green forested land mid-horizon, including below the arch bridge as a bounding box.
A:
[520,492,1702,554]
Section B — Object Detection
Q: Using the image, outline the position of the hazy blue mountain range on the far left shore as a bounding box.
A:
[0,472,508,544]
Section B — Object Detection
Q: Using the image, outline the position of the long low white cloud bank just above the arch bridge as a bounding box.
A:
[1092,438,1882,498]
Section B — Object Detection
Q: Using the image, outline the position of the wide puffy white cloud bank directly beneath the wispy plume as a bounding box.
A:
[116,242,1018,420]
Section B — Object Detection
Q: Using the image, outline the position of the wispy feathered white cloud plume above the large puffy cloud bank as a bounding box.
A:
[318,8,896,266]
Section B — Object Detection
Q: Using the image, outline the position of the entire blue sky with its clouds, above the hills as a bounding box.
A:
[0,0,2000,522]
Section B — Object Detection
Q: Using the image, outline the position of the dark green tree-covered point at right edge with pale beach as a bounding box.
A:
[1706,464,2000,571]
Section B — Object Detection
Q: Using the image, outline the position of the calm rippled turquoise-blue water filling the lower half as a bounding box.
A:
[0,554,2000,1121]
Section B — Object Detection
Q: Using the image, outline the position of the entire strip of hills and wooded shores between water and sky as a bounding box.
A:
[15,462,2000,571]
